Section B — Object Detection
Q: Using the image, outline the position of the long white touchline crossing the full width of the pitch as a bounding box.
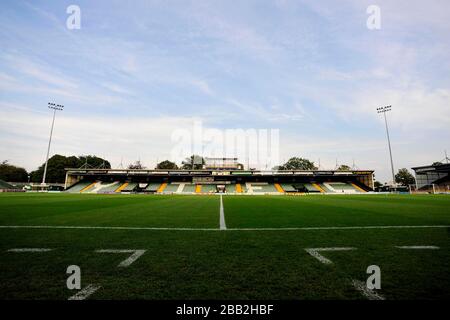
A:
[0,225,450,231]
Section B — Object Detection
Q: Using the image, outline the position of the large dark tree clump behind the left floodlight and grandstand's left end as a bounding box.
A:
[30,154,111,183]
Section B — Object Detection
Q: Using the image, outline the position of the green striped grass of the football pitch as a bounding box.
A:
[0,193,450,299]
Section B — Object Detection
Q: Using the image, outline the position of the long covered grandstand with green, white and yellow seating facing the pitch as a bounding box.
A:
[65,168,374,195]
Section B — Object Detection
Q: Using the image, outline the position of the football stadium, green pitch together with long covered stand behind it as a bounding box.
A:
[0,158,450,300]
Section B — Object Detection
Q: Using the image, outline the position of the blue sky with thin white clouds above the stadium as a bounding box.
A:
[0,0,450,182]
